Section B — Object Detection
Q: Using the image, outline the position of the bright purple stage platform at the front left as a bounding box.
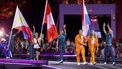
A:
[0,58,56,69]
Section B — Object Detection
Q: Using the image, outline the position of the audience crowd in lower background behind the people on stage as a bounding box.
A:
[0,33,121,58]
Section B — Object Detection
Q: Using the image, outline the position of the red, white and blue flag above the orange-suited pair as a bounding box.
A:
[82,0,91,36]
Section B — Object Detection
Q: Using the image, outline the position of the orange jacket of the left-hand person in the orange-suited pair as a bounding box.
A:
[75,34,85,49]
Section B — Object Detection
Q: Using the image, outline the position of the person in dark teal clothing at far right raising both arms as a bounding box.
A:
[103,23,115,65]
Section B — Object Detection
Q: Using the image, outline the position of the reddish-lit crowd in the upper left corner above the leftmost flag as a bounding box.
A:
[0,0,26,19]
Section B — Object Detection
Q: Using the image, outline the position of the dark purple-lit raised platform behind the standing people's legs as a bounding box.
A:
[14,53,122,63]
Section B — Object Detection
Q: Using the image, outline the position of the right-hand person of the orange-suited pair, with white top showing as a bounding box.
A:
[87,30,98,65]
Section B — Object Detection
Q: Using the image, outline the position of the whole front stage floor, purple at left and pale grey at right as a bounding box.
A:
[0,59,122,69]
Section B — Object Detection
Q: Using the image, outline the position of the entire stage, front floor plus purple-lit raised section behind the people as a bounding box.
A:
[0,53,122,69]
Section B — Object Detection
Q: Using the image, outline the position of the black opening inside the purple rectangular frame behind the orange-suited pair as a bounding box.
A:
[64,15,111,41]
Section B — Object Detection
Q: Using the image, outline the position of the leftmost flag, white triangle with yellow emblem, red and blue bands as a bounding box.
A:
[12,6,32,42]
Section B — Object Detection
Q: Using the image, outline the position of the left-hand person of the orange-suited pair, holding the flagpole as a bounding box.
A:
[75,29,87,65]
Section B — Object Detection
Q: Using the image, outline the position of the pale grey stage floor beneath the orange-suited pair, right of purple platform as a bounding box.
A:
[48,61,122,69]
